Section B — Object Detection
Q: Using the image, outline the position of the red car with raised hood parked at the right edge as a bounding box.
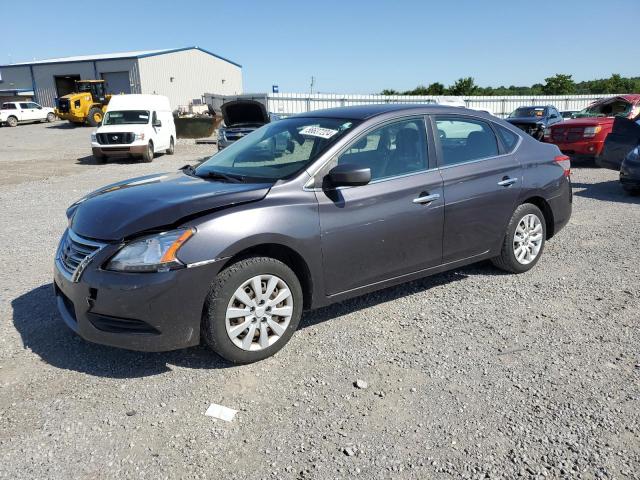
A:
[543,94,640,159]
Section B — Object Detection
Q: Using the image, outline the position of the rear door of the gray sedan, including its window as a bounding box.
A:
[432,115,522,263]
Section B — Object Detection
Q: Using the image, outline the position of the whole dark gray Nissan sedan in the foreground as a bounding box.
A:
[54,105,572,363]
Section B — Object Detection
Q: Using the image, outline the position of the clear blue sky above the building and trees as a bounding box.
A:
[0,0,640,93]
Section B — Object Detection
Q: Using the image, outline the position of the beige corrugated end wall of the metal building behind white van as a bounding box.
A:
[138,50,242,109]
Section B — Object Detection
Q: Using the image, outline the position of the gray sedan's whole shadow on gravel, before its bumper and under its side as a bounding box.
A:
[11,262,498,378]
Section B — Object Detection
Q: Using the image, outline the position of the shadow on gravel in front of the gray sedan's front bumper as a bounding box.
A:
[11,283,233,378]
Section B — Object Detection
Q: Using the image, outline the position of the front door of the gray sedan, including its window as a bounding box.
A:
[315,116,444,295]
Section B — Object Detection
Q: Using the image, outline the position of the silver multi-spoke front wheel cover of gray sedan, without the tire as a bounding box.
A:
[225,274,293,351]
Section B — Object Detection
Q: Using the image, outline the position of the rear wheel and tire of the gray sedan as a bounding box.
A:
[491,203,547,273]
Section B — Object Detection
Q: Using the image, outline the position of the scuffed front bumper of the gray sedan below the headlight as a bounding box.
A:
[54,253,222,352]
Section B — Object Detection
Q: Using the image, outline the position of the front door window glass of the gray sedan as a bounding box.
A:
[337,118,428,180]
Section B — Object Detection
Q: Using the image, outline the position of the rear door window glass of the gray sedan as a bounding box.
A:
[436,117,498,166]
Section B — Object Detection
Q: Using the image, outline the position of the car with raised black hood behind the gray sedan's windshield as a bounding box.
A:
[218,99,280,150]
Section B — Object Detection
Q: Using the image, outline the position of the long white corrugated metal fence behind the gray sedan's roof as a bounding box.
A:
[267,93,613,117]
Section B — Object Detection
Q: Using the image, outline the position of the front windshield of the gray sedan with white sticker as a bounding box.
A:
[195,117,357,182]
